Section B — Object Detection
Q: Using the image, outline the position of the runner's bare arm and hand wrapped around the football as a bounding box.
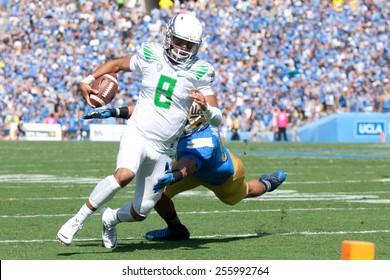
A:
[80,55,133,108]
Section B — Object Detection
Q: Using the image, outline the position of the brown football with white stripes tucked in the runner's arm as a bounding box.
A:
[89,73,118,108]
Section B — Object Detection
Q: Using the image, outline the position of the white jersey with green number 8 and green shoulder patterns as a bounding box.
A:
[128,42,214,153]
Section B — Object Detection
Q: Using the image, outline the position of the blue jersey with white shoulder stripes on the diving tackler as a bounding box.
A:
[177,125,234,186]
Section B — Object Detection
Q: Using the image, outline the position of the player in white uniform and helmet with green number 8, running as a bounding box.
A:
[57,14,222,249]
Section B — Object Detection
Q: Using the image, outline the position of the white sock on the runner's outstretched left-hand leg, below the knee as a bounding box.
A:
[89,175,121,209]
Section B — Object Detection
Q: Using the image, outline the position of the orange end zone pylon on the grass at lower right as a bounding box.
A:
[341,240,375,260]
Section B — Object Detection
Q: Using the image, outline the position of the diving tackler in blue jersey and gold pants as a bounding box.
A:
[84,102,287,240]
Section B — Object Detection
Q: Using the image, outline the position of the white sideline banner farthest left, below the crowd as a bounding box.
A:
[10,123,62,141]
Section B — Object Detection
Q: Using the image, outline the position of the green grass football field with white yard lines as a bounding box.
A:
[0,141,390,260]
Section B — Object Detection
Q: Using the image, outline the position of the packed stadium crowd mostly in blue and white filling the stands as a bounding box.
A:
[0,0,390,141]
